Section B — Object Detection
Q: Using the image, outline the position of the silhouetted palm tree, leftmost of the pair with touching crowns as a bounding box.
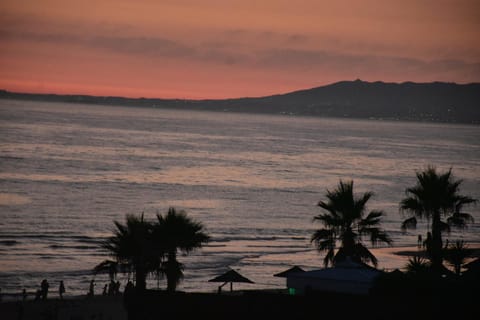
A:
[102,214,162,291]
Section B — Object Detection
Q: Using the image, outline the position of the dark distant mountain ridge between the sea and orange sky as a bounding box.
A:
[0,80,480,124]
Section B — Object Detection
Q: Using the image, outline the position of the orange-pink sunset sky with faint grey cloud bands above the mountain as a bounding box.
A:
[0,0,480,99]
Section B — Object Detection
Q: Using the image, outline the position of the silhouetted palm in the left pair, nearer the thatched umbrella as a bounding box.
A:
[154,208,210,292]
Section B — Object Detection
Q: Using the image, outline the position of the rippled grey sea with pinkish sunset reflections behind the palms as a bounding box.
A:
[0,100,480,296]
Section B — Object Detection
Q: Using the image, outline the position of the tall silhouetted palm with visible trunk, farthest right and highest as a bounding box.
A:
[400,166,477,270]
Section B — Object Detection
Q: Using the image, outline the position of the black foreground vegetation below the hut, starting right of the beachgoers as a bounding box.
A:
[127,284,480,319]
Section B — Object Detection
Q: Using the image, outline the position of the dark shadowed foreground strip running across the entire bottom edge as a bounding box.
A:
[0,284,480,320]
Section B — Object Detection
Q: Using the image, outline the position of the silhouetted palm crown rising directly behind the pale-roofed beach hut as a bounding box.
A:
[312,180,392,266]
